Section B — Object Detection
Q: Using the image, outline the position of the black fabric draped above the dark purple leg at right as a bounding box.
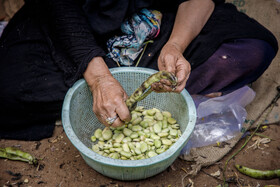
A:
[184,3,278,68]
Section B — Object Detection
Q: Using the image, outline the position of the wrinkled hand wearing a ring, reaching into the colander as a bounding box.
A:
[84,57,131,127]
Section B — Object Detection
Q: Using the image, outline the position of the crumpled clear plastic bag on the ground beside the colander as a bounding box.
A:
[181,86,256,154]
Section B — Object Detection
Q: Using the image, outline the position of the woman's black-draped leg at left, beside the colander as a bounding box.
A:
[0,5,68,140]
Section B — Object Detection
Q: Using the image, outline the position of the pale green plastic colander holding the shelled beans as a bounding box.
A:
[62,67,196,180]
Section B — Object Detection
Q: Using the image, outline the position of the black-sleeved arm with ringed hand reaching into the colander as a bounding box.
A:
[43,0,130,126]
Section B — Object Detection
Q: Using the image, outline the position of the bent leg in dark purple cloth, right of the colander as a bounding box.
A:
[186,39,276,94]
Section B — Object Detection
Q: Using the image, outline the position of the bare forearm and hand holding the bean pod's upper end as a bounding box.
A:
[153,0,214,92]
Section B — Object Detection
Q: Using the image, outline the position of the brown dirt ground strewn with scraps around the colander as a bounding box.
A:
[0,123,280,187]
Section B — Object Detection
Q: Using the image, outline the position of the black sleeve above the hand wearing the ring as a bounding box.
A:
[48,0,105,69]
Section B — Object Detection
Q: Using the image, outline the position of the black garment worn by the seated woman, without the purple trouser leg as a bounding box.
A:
[0,0,278,140]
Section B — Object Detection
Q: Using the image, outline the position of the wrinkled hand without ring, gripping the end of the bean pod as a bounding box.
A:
[152,43,191,93]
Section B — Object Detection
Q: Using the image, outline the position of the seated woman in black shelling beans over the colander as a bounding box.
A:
[0,0,278,140]
